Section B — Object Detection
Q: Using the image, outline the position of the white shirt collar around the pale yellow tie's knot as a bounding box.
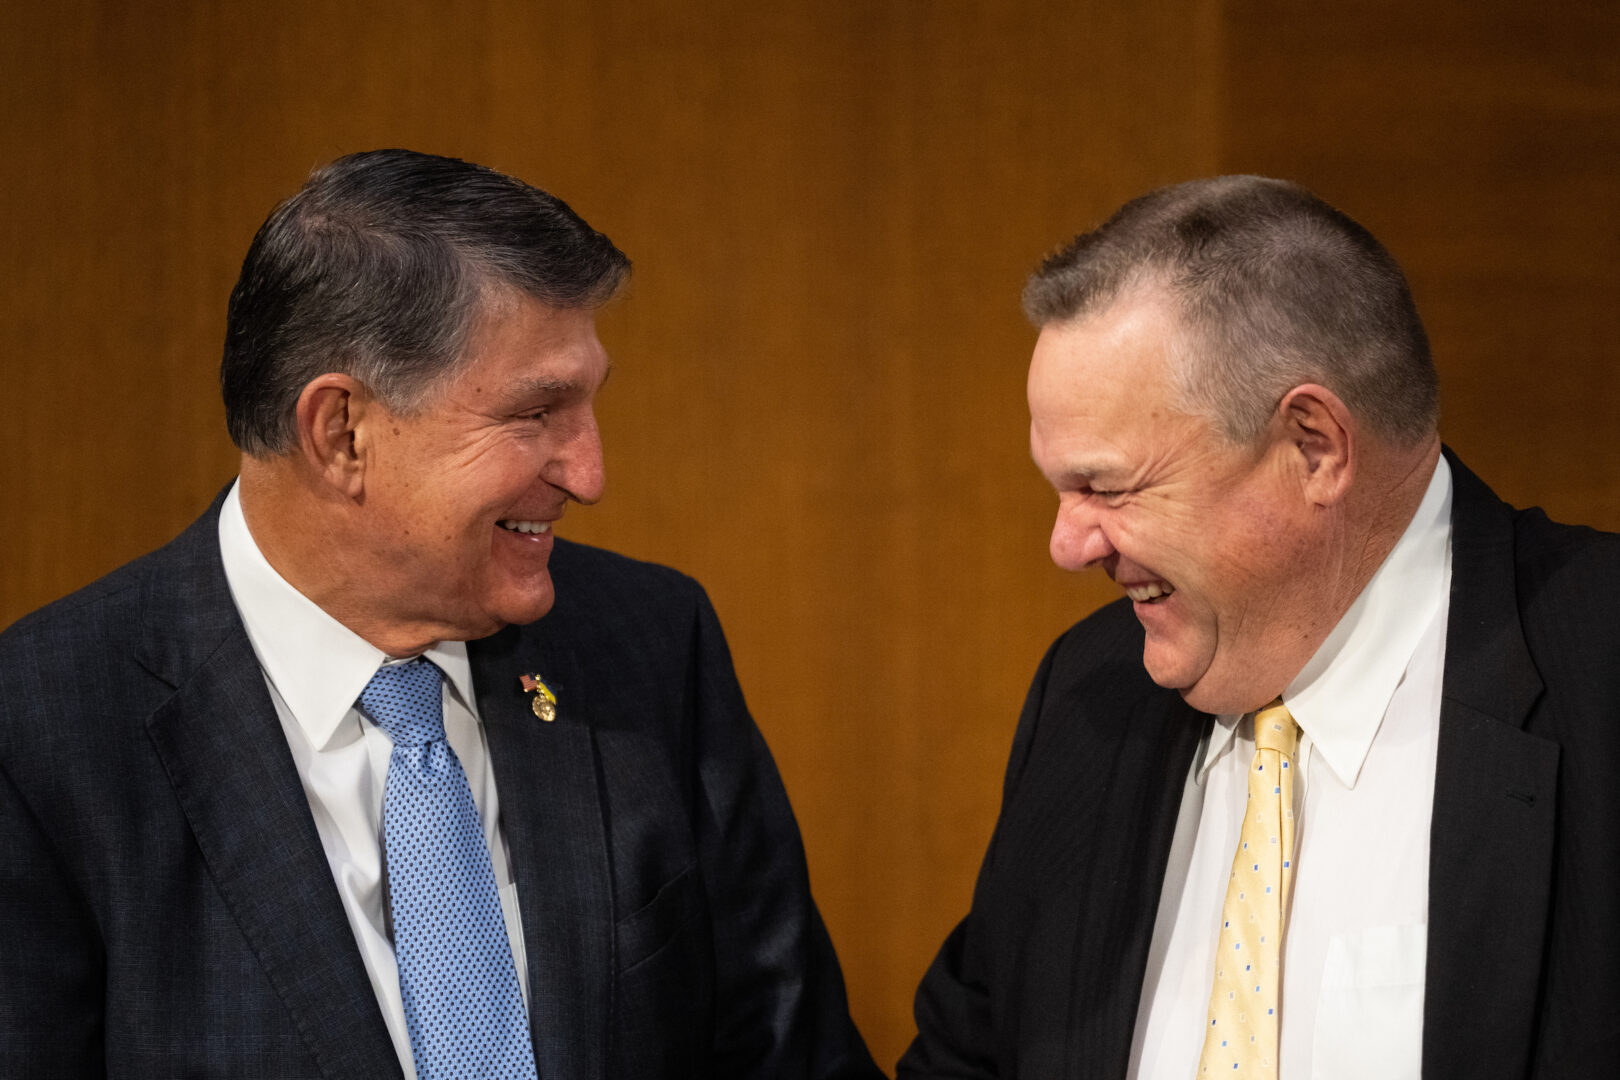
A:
[1197,457,1452,789]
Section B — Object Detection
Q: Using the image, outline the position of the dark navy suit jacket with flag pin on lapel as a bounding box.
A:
[0,502,881,1080]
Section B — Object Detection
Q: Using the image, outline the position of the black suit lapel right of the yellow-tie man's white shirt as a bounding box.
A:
[1422,452,1558,1077]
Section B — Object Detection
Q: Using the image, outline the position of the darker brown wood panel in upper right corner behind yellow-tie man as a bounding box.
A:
[1221,0,1620,529]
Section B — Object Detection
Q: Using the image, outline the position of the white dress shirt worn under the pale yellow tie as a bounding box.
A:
[1129,458,1452,1080]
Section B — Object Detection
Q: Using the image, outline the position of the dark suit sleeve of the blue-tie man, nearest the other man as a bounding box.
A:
[693,591,883,1080]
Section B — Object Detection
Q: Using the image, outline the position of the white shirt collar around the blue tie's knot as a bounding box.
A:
[219,483,476,751]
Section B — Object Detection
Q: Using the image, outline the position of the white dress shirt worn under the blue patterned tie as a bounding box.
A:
[219,484,528,1080]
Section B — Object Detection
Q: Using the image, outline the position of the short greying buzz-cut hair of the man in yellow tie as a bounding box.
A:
[1024,176,1439,445]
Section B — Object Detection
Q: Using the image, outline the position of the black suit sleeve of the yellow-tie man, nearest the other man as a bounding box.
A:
[899,638,1063,1080]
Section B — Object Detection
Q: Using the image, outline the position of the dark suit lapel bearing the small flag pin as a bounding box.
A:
[468,623,612,1080]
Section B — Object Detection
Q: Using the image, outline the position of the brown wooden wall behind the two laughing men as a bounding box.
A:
[0,0,1620,1064]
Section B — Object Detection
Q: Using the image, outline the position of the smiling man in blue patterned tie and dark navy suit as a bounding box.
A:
[0,151,880,1080]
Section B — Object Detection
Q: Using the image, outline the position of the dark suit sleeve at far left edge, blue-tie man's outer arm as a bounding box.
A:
[0,744,105,1080]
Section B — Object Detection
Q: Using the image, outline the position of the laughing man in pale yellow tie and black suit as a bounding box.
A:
[899,176,1620,1080]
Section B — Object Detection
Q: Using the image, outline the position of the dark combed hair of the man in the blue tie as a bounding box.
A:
[219,151,630,455]
